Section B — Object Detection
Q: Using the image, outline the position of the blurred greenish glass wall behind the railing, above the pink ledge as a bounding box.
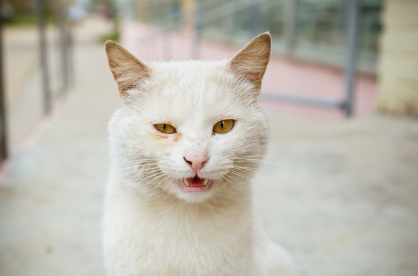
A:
[115,0,384,73]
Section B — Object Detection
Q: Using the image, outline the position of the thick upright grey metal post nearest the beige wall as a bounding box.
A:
[344,0,359,117]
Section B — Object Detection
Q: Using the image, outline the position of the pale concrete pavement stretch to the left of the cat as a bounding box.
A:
[0,18,116,276]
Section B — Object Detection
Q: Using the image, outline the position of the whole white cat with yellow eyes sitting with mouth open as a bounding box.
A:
[103,33,293,276]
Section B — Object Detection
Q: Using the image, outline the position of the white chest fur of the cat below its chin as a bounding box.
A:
[104,182,257,276]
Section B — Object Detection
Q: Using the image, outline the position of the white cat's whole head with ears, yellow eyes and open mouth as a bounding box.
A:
[106,33,271,202]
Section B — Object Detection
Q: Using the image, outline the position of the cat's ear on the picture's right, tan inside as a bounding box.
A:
[227,32,271,92]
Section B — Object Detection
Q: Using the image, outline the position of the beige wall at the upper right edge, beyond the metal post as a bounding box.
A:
[377,0,418,117]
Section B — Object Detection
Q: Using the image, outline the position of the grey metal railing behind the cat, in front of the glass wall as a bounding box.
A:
[134,0,366,117]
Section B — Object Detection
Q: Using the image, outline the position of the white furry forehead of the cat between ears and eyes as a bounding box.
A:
[140,61,255,124]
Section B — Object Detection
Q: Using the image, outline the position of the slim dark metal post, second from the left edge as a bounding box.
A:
[35,0,51,114]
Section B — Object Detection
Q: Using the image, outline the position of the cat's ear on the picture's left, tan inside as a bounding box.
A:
[105,40,151,98]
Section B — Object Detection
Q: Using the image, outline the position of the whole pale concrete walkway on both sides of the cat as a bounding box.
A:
[0,16,418,276]
